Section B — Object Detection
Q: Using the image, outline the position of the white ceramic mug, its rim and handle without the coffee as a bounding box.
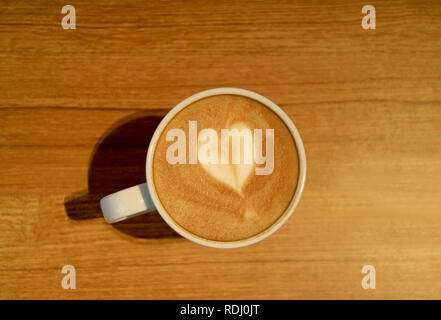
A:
[101,88,306,248]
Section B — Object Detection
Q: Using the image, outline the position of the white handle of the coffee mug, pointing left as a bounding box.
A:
[100,183,156,223]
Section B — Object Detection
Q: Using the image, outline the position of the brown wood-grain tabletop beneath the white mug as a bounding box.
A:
[0,0,441,299]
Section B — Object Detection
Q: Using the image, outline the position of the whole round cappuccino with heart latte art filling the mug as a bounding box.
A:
[153,94,299,241]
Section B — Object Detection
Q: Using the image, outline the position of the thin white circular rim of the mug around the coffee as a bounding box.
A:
[146,87,306,248]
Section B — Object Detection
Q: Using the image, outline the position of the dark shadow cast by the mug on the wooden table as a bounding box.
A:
[64,110,180,238]
